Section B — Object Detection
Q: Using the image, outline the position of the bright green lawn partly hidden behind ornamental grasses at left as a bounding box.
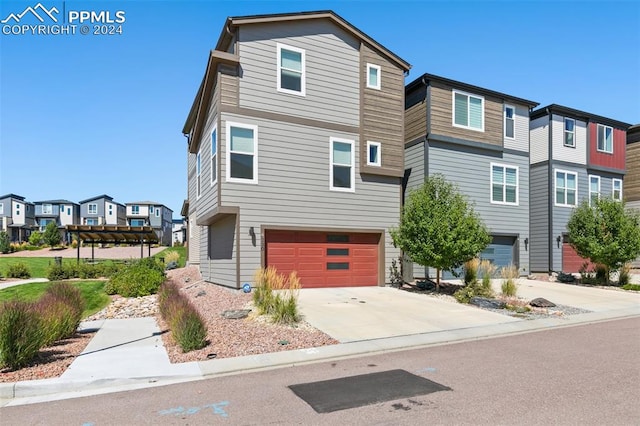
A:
[0,280,111,318]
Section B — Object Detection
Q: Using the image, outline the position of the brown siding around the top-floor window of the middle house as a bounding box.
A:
[430,82,504,146]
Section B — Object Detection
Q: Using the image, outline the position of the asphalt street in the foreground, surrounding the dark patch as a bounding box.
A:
[0,318,640,426]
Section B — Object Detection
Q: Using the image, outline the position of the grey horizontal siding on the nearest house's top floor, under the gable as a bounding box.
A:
[239,20,360,126]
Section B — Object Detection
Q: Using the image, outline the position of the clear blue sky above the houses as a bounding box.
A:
[0,0,640,217]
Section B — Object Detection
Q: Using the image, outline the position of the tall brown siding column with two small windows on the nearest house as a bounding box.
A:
[360,44,404,176]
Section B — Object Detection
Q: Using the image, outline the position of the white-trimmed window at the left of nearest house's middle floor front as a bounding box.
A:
[226,121,258,183]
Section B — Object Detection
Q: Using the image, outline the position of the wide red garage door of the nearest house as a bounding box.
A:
[265,230,380,288]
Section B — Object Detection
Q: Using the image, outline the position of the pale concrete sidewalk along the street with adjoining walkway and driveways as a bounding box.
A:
[0,280,640,406]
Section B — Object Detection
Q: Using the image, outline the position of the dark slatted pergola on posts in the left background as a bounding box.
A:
[66,225,158,262]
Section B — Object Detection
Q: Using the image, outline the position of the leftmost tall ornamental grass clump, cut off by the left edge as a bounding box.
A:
[0,301,43,369]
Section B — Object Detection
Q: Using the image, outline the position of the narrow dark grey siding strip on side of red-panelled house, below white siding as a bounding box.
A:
[529,164,550,272]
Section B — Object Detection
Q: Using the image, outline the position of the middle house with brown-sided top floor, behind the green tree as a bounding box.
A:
[405,74,538,278]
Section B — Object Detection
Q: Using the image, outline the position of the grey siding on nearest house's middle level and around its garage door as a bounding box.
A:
[221,114,402,282]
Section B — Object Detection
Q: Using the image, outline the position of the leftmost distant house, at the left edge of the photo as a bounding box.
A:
[0,194,36,242]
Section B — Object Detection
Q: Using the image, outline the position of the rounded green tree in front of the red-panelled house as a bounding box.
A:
[567,198,640,282]
